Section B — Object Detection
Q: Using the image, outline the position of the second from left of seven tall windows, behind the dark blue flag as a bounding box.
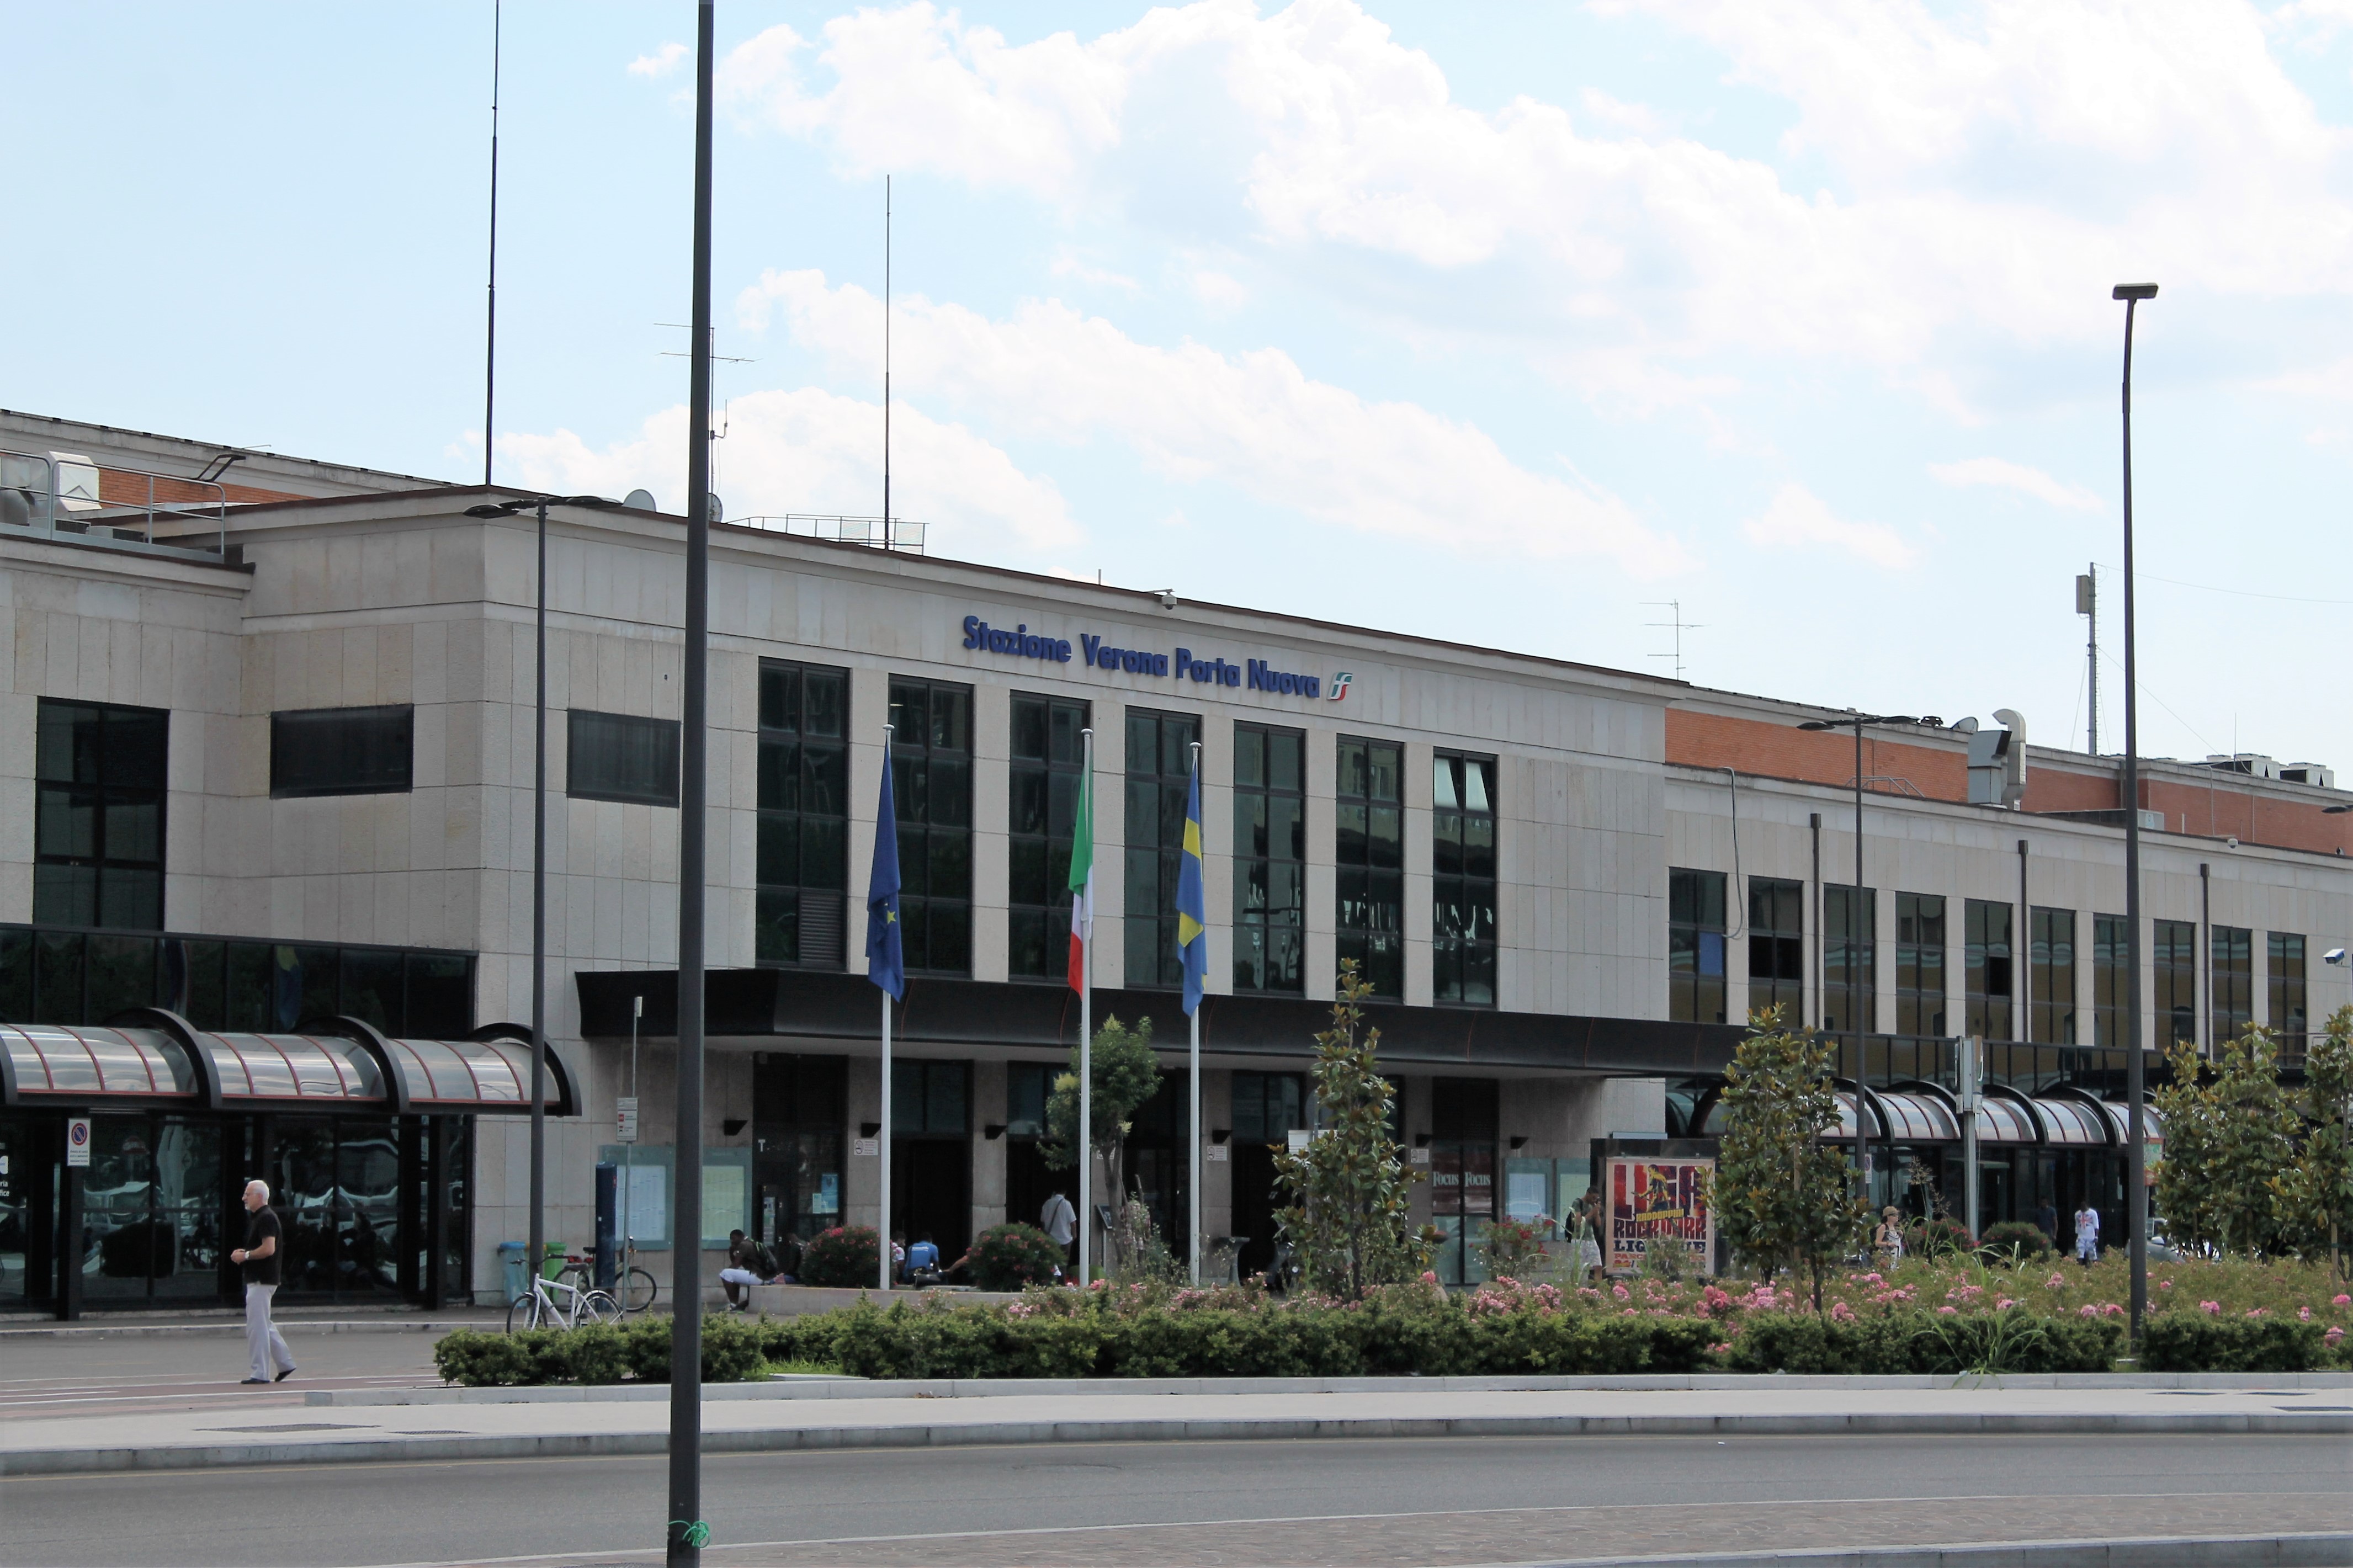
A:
[889,676,972,975]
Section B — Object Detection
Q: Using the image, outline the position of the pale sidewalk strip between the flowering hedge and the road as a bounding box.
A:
[0,1375,2353,1476]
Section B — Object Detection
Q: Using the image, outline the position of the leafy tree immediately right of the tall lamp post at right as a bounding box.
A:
[2150,1024,2301,1257]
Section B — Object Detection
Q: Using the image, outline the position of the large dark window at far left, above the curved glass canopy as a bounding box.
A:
[33,697,172,930]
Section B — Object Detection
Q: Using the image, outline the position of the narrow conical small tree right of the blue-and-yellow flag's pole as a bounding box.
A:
[1276,958,1431,1302]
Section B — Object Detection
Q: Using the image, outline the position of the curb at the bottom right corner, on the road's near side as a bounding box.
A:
[1489,1533,2353,1568]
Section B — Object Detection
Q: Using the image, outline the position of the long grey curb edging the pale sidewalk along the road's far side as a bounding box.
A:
[14,1412,2353,1469]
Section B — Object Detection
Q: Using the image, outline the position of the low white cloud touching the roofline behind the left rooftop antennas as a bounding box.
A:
[499,389,1085,560]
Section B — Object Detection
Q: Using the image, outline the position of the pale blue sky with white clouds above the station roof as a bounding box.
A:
[0,0,2353,779]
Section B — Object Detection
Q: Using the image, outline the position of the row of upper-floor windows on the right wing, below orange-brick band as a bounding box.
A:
[1666,869,2308,1045]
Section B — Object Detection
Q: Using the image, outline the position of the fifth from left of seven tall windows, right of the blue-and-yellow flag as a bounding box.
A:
[1233,723,1308,996]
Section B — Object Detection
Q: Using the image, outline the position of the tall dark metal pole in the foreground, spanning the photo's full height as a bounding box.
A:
[663,0,713,1568]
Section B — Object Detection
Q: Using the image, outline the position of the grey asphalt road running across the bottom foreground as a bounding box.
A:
[0,1436,2353,1568]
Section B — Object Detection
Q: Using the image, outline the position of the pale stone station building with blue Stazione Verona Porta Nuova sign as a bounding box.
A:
[0,412,2353,1311]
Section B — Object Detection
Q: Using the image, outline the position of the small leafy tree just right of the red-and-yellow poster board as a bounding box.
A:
[1713,1008,1871,1311]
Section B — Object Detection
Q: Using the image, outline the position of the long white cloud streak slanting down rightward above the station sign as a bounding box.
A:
[736,271,1690,577]
